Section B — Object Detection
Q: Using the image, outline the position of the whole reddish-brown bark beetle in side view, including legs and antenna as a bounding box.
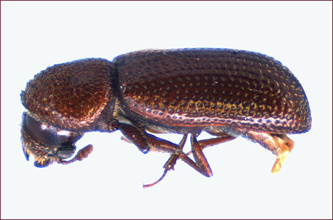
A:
[21,48,312,187]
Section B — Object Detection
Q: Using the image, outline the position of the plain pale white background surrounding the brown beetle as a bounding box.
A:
[1,2,332,218]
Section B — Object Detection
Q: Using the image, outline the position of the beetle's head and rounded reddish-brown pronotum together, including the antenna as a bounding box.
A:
[21,59,117,167]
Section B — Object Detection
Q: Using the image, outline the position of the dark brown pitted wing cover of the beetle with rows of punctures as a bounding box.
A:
[115,49,311,133]
